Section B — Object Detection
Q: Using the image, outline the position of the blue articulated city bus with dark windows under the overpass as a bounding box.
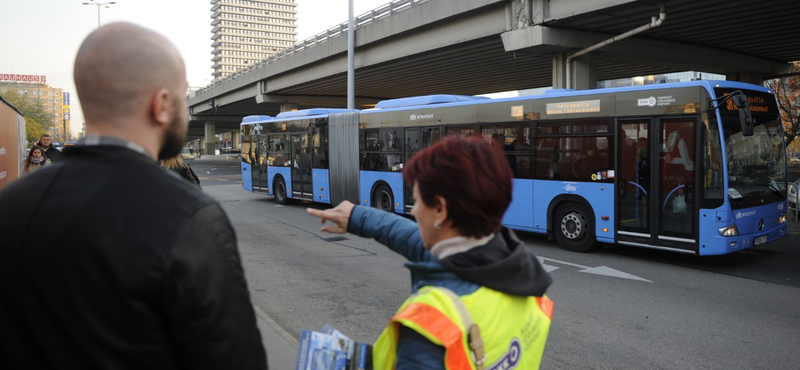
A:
[242,81,788,255]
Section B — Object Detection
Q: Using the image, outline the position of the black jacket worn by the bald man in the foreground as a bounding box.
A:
[0,145,267,369]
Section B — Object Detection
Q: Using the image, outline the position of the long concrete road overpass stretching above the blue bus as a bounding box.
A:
[189,0,800,155]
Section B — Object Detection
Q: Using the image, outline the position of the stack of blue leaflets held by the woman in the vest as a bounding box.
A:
[295,324,372,370]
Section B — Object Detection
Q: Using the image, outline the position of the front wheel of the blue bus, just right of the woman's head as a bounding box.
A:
[553,202,597,253]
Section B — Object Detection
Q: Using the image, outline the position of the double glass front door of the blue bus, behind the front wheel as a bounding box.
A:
[616,117,697,252]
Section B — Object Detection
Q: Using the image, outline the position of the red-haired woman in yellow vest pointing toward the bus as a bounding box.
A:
[308,136,553,370]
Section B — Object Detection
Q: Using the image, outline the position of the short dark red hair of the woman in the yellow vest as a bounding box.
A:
[403,136,512,237]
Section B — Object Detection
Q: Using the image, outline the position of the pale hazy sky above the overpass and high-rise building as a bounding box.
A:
[0,0,391,135]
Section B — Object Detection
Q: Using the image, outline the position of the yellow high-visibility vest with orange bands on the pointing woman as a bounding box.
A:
[372,287,553,370]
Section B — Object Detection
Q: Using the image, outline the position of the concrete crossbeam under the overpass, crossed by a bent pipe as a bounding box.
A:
[500,26,791,75]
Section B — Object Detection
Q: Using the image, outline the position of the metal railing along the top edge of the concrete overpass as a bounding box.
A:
[192,0,433,96]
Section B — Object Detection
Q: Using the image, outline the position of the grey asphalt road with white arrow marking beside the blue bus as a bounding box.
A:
[190,160,800,369]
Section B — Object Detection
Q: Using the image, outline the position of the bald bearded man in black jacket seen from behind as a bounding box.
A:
[0,23,267,369]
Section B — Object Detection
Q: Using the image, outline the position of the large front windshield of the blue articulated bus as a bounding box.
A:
[722,115,786,209]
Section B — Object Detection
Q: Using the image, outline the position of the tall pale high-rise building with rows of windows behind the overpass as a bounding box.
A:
[211,0,297,80]
